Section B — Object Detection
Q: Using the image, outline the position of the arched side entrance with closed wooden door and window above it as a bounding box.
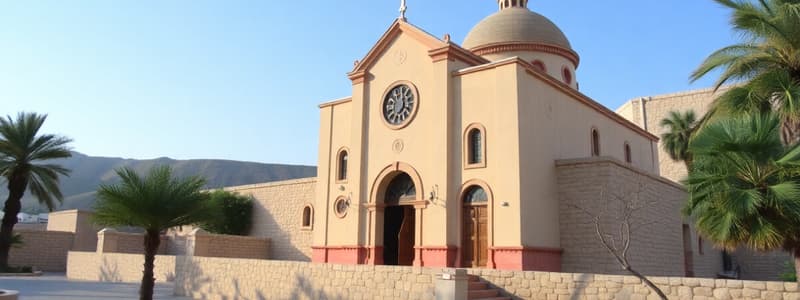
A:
[461,185,489,268]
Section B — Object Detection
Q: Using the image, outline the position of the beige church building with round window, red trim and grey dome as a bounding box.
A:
[312,0,685,275]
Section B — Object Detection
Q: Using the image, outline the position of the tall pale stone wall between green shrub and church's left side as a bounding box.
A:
[226,178,316,261]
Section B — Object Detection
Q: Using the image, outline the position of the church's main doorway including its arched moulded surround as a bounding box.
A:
[367,162,427,265]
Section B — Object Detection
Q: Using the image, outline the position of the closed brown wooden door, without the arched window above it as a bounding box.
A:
[461,205,489,268]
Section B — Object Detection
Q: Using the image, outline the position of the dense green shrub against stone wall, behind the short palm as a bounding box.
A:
[200,190,253,235]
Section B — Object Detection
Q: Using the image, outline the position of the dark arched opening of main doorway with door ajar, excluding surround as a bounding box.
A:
[383,172,417,266]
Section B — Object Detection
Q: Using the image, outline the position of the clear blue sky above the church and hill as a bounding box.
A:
[0,0,736,165]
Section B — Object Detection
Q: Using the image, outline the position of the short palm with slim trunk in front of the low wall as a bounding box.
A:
[94,166,216,300]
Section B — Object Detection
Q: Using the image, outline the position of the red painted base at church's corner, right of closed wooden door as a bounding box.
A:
[489,247,562,272]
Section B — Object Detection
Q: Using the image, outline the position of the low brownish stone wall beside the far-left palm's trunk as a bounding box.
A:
[9,230,75,272]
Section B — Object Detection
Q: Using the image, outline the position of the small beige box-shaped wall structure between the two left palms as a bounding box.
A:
[47,209,100,251]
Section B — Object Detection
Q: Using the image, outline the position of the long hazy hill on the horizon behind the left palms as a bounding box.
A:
[0,152,317,213]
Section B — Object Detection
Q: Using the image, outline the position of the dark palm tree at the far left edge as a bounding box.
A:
[0,113,72,270]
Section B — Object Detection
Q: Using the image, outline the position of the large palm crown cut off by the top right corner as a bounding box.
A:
[691,0,800,144]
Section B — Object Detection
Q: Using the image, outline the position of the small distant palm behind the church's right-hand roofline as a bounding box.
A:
[661,110,697,172]
